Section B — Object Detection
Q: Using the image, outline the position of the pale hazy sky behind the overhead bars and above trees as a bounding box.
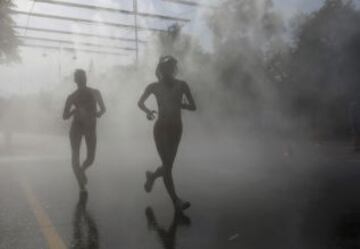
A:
[0,0,323,95]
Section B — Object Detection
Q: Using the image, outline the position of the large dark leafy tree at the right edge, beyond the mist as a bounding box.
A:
[285,0,360,135]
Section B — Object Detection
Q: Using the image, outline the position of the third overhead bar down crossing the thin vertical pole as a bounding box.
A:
[14,25,146,43]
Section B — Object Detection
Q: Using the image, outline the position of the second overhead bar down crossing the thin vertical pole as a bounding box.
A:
[10,10,167,32]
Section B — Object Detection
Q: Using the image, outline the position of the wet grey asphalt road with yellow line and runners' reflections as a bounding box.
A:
[0,136,360,249]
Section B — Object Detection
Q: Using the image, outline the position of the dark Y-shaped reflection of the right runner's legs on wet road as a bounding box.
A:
[145,207,191,249]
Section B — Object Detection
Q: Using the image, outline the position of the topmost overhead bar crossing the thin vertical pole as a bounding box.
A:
[36,0,191,22]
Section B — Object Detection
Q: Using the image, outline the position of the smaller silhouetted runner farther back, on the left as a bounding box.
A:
[63,69,105,190]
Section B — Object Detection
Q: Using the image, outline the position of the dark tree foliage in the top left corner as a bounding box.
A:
[0,0,20,64]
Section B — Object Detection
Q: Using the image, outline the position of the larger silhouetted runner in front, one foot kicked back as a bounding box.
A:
[138,56,196,210]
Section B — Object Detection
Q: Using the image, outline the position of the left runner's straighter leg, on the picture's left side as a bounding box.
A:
[70,124,84,189]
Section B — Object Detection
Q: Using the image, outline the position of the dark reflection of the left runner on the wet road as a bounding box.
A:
[71,191,100,249]
